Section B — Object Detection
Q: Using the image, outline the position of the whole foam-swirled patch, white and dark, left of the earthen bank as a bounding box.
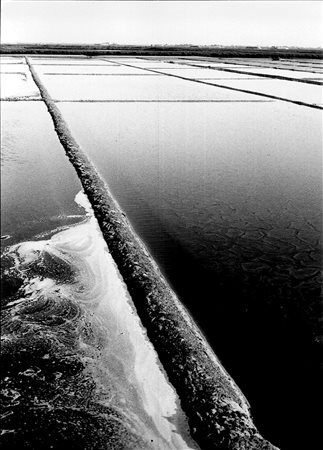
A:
[0,193,197,450]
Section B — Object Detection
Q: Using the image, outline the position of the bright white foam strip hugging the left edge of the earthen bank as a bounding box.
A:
[71,192,197,449]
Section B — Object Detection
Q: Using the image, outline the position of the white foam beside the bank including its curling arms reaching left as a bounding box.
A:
[4,192,198,450]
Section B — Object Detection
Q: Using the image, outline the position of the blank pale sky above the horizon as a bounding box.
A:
[1,0,323,47]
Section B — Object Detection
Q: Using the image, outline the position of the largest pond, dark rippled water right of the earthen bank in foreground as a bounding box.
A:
[59,102,322,450]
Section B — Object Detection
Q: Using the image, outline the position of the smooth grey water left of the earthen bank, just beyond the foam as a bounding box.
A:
[1,102,84,246]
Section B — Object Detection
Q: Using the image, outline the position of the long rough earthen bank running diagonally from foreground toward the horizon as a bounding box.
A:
[26,57,276,450]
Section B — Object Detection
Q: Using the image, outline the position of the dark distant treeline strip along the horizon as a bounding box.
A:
[0,44,323,59]
